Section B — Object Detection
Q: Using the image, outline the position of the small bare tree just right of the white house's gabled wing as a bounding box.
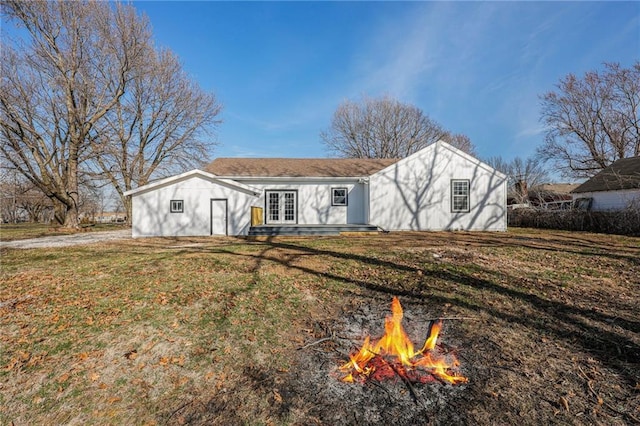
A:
[486,156,549,204]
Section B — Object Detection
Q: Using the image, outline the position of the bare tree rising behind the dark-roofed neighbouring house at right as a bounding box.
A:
[539,62,640,178]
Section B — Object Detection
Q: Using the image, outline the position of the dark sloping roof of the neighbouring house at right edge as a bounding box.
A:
[571,157,640,193]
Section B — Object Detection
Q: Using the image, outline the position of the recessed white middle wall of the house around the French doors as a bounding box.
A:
[236,178,366,225]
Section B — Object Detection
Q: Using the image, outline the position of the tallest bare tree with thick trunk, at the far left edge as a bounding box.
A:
[0,1,150,227]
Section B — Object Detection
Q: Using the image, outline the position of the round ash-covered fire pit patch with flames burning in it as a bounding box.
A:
[258,295,472,426]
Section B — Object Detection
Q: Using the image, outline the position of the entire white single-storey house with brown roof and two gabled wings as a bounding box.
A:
[125,141,507,237]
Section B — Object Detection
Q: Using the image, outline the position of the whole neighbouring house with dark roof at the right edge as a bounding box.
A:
[571,157,640,211]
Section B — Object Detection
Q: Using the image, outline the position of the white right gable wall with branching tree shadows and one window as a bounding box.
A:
[369,142,507,231]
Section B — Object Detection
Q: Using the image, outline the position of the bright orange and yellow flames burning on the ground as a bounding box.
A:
[340,297,467,384]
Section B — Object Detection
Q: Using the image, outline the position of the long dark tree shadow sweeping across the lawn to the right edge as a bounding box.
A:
[212,239,640,386]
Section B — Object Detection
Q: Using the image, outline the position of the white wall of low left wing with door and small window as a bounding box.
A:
[132,176,262,238]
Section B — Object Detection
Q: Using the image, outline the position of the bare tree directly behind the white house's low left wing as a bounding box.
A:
[88,49,222,221]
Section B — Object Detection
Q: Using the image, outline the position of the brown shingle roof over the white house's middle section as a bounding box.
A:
[204,158,399,177]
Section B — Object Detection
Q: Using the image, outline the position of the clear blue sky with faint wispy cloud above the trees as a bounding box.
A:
[134,1,640,164]
